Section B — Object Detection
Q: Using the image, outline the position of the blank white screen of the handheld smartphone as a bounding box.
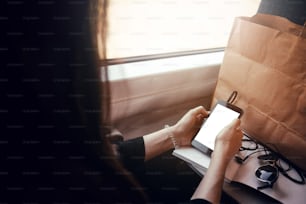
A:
[194,104,240,150]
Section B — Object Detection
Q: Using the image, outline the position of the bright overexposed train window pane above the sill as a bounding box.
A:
[107,0,260,59]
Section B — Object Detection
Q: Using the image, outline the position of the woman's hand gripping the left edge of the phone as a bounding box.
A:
[170,106,208,146]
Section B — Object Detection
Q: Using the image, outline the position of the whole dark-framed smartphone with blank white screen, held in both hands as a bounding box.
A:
[191,101,243,153]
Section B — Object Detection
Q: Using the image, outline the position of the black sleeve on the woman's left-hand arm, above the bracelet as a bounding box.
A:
[117,137,145,172]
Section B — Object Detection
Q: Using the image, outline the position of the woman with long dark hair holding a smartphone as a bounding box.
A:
[0,0,242,203]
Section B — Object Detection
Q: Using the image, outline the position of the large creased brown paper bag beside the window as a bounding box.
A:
[212,14,306,171]
